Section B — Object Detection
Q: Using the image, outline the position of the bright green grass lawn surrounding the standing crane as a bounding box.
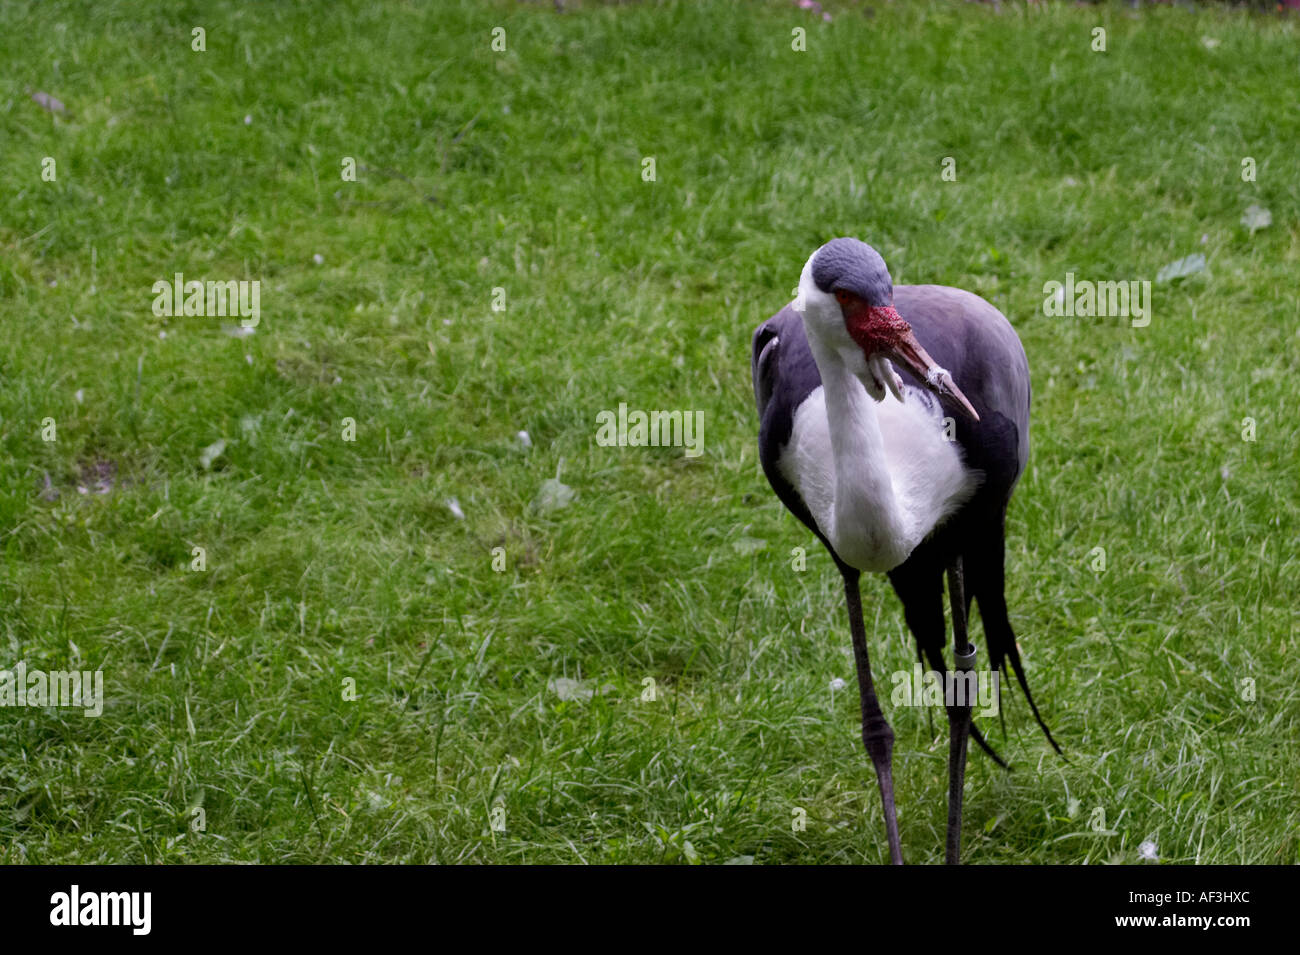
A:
[0,0,1300,863]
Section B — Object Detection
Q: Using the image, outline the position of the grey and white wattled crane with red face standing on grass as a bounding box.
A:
[753,238,1061,864]
